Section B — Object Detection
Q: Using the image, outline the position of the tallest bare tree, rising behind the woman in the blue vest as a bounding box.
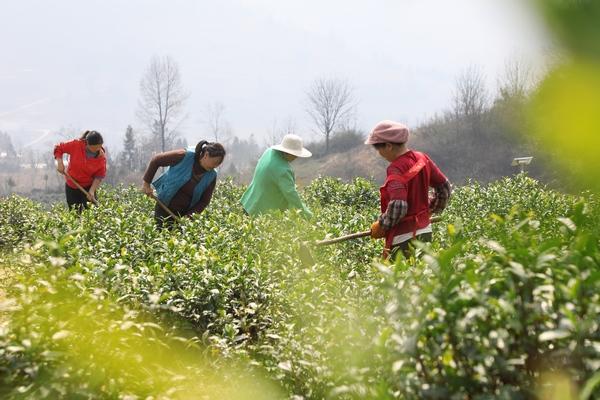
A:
[138,56,189,151]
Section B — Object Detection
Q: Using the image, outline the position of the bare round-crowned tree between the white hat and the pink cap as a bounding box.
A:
[306,78,355,153]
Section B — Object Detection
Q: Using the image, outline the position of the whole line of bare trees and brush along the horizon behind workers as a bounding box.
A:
[0,57,561,192]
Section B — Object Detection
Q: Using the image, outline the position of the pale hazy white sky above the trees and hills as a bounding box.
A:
[0,0,550,152]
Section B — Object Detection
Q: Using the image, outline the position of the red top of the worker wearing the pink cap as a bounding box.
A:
[379,150,447,249]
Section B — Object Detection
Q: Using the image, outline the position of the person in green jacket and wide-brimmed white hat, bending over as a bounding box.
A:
[241,135,312,217]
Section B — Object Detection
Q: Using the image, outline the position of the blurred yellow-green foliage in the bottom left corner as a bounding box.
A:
[0,260,280,399]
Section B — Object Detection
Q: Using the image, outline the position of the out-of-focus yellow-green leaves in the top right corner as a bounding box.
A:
[528,0,600,191]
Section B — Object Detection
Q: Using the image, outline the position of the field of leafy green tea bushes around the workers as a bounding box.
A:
[0,175,600,399]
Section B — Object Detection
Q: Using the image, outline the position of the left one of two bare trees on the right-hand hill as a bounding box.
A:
[453,66,489,118]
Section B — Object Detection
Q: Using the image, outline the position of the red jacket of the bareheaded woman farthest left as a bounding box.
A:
[54,139,106,189]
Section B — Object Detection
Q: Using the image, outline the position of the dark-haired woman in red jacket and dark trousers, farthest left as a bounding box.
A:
[54,131,106,211]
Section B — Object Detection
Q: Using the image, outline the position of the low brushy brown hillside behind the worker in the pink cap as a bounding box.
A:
[293,126,564,189]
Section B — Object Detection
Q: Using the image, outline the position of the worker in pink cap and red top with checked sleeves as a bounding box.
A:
[365,121,451,260]
